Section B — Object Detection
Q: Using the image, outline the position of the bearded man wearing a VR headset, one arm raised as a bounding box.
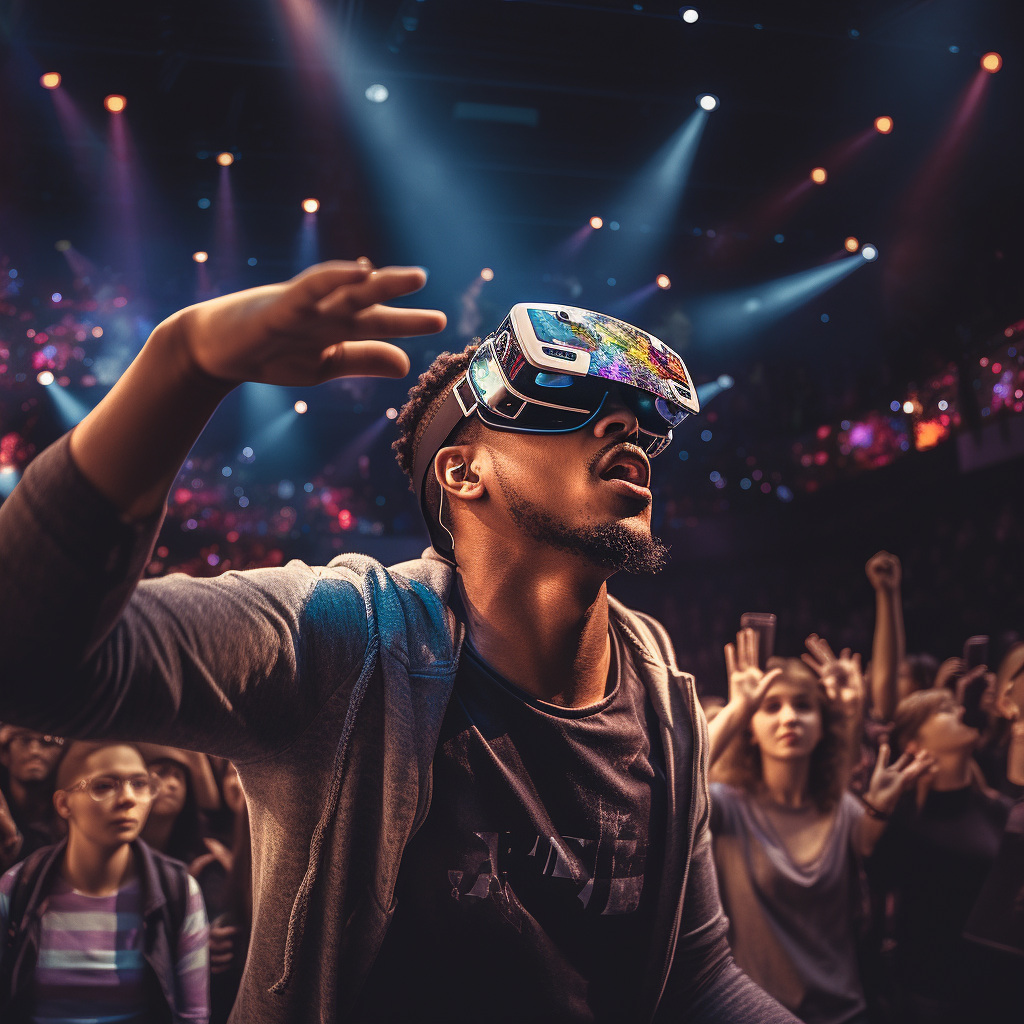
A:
[0,261,793,1022]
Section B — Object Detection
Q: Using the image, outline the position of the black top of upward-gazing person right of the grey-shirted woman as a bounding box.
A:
[868,786,1010,1000]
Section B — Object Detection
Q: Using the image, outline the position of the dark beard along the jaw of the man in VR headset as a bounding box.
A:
[497,472,669,572]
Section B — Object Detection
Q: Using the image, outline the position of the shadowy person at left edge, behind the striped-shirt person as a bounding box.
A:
[0,725,63,868]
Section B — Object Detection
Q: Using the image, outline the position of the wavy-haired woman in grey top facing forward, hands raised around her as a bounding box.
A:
[709,630,931,1024]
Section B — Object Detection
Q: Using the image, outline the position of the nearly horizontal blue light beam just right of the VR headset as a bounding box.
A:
[689,253,866,342]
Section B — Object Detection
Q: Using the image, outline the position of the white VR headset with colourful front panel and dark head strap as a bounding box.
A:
[413,302,700,562]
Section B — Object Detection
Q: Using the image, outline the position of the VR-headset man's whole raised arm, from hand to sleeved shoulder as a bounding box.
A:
[0,264,443,756]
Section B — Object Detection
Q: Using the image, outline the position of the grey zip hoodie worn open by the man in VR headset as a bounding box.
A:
[0,436,794,1024]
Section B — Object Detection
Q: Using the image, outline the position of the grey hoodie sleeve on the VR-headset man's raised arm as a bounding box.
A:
[0,435,368,761]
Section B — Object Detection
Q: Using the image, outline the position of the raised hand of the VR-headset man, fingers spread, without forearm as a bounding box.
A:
[168,260,445,386]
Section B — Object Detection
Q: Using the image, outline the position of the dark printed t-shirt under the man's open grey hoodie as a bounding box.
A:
[354,631,667,1024]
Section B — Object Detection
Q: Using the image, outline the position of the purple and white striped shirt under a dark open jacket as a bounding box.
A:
[0,865,210,1024]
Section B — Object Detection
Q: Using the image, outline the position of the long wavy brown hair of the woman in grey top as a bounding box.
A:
[713,657,852,812]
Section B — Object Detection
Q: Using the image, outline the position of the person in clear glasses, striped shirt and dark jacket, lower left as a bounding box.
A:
[0,741,209,1024]
